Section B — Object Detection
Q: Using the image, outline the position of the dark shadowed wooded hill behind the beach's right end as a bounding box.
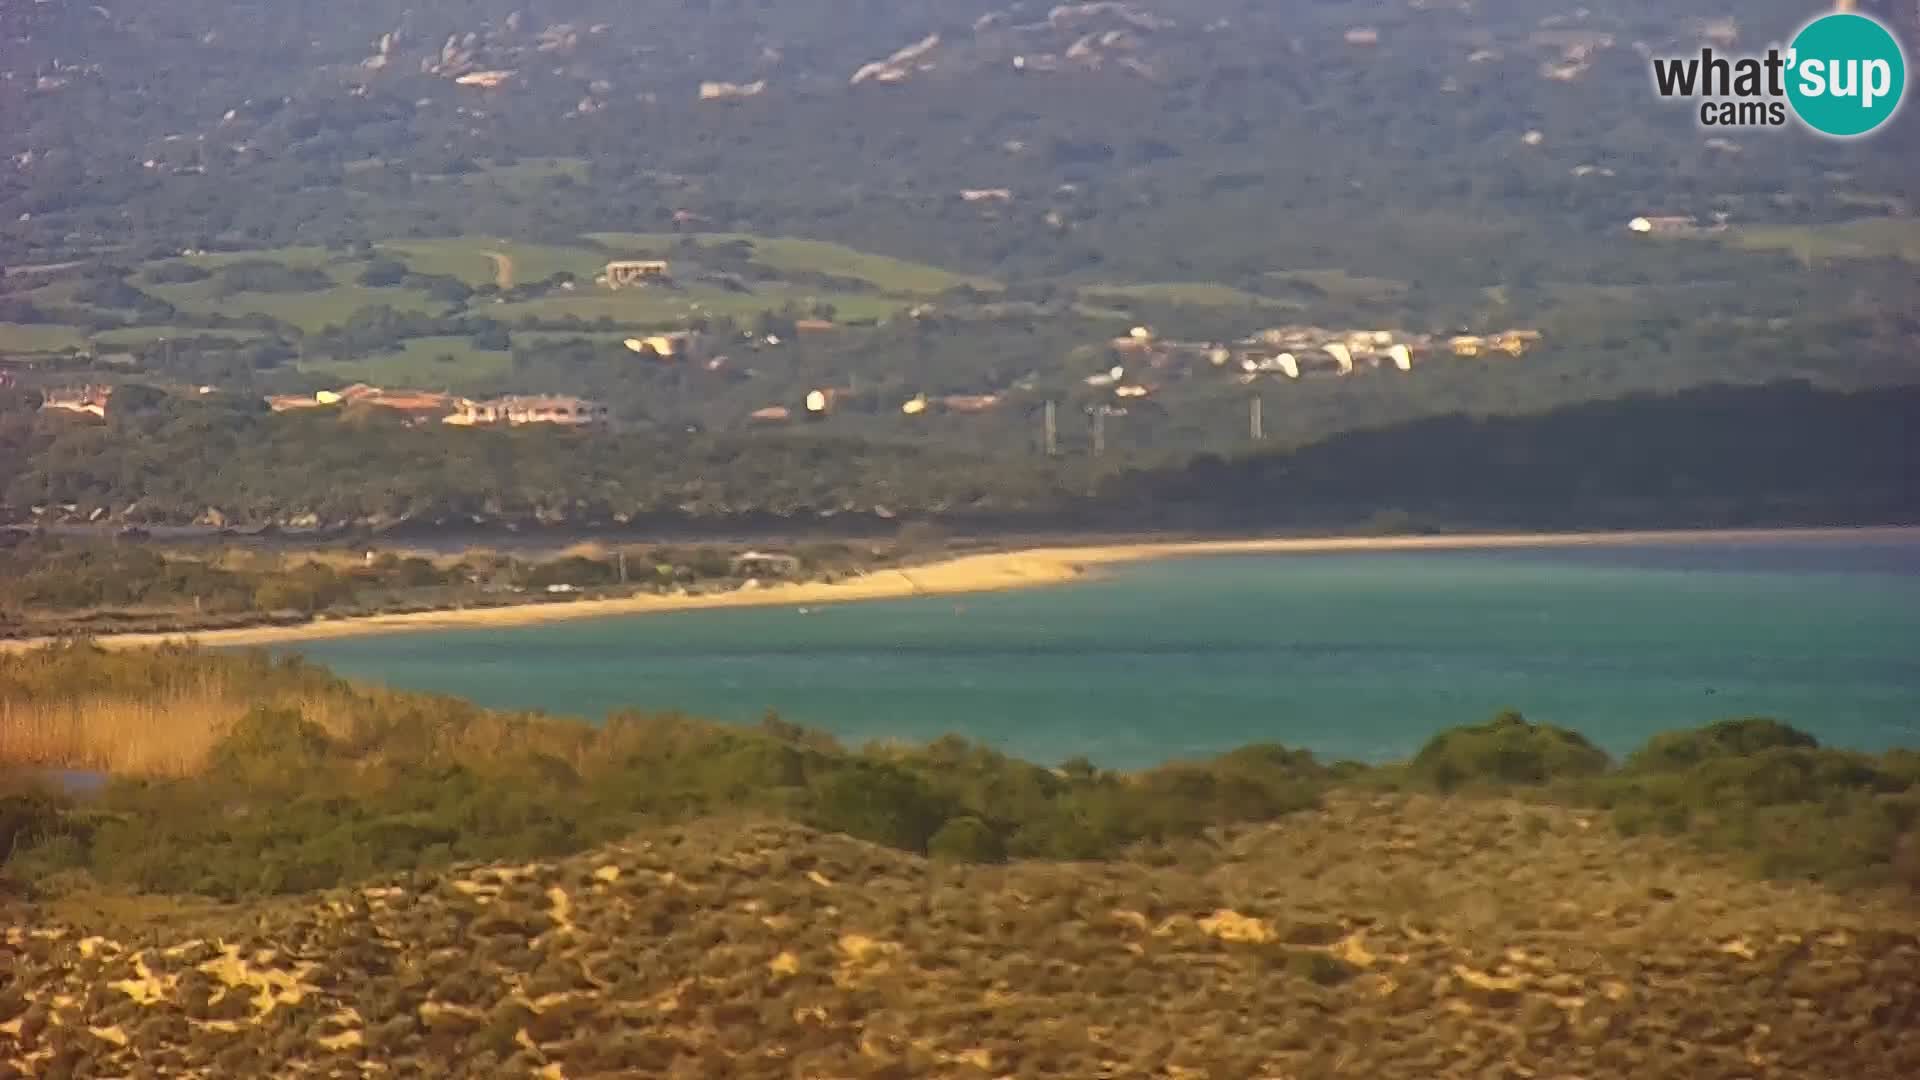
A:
[1100,382,1920,528]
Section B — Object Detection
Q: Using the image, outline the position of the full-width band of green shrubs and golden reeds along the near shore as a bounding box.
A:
[0,646,1920,897]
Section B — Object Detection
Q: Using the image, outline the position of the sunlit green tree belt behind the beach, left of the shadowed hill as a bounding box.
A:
[0,384,1075,527]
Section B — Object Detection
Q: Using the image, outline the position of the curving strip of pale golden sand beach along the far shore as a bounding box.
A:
[0,527,1920,651]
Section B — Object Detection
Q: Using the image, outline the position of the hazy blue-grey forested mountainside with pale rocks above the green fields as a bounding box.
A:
[0,0,1920,269]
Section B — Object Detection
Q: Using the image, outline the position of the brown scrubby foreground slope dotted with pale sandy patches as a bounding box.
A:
[0,798,1920,1080]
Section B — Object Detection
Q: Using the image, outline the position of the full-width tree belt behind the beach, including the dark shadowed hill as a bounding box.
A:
[0,382,1920,530]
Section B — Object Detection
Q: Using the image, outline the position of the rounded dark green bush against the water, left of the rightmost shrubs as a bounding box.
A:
[1409,711,1611,792]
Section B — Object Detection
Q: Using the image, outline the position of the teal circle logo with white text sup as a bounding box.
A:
[1788,13,1907,138]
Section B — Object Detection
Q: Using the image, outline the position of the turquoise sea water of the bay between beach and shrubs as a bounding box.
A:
[301,538,1920,767]
